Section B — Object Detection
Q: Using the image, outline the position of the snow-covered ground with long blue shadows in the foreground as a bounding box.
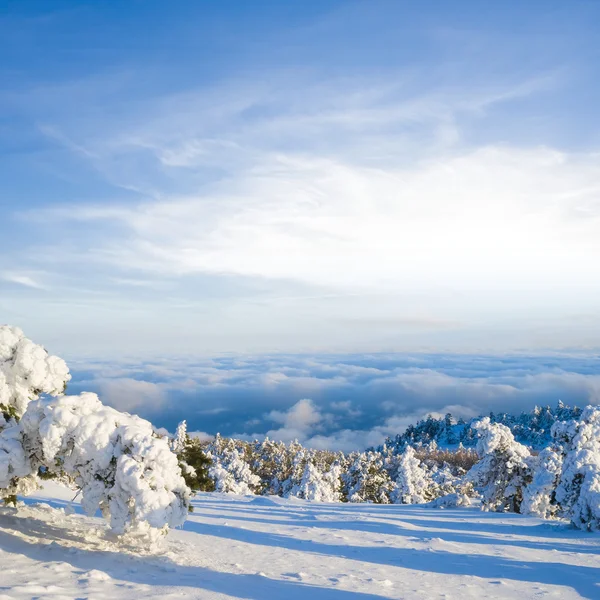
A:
[0,484,600,600]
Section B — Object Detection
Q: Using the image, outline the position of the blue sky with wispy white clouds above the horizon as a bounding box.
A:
[0,0,600,440]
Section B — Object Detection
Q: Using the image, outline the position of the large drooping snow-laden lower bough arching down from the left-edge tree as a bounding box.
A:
[19,392,189,533]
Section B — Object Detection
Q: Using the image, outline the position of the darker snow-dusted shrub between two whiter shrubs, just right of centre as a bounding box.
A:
[342,452,394,504]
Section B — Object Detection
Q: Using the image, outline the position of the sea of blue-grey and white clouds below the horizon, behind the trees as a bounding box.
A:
[64,354,600,451]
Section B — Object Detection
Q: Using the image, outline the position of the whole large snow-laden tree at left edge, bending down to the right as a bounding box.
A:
[0,326,189,533]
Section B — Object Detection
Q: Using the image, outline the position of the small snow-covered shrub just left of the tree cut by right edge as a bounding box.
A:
[521,448,562,519]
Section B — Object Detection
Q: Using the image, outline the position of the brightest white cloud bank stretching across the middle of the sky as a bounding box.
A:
[44,146,600,298]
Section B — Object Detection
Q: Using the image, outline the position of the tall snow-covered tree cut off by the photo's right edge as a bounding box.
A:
[552,406,600,530]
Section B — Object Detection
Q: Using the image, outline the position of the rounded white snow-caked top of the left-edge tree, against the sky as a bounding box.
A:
[0,325,71,417]
